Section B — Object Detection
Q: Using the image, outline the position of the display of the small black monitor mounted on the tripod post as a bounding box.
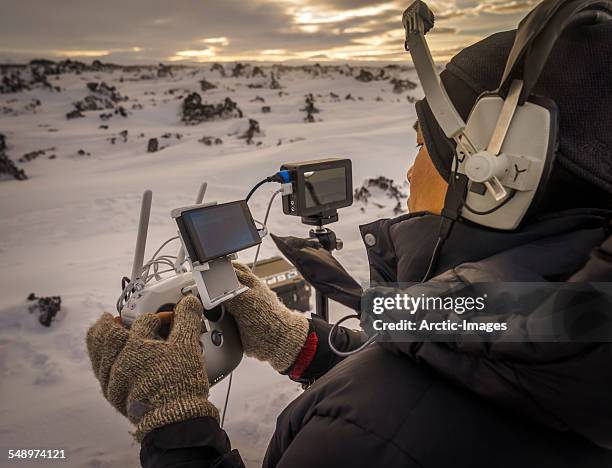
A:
[304,167,346,208]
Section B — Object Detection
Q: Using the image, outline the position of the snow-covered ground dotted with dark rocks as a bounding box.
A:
[0,65,421,467]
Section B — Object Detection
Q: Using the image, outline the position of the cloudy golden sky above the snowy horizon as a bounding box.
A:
[0,0,537,63]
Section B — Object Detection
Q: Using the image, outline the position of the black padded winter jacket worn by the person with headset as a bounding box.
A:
[141,211,612,468]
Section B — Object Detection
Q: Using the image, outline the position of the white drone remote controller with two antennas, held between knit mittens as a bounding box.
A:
[117,183,247,387]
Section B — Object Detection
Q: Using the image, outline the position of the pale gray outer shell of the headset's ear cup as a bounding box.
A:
[458,93,558,230]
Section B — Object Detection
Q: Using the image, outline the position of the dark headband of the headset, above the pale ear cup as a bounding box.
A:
[499,0,612,103]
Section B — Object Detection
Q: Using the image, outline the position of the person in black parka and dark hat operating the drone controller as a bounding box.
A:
[87,4,612,468]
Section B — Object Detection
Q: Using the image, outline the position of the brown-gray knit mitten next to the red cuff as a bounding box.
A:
[225,263,308,372]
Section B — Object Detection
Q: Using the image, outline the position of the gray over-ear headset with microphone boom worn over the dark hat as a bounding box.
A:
[403,0,612,230]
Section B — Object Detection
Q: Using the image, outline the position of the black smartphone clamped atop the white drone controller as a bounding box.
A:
[181,200,261,262]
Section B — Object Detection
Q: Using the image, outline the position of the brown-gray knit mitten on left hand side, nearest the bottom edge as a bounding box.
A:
[87,296,219,441]
